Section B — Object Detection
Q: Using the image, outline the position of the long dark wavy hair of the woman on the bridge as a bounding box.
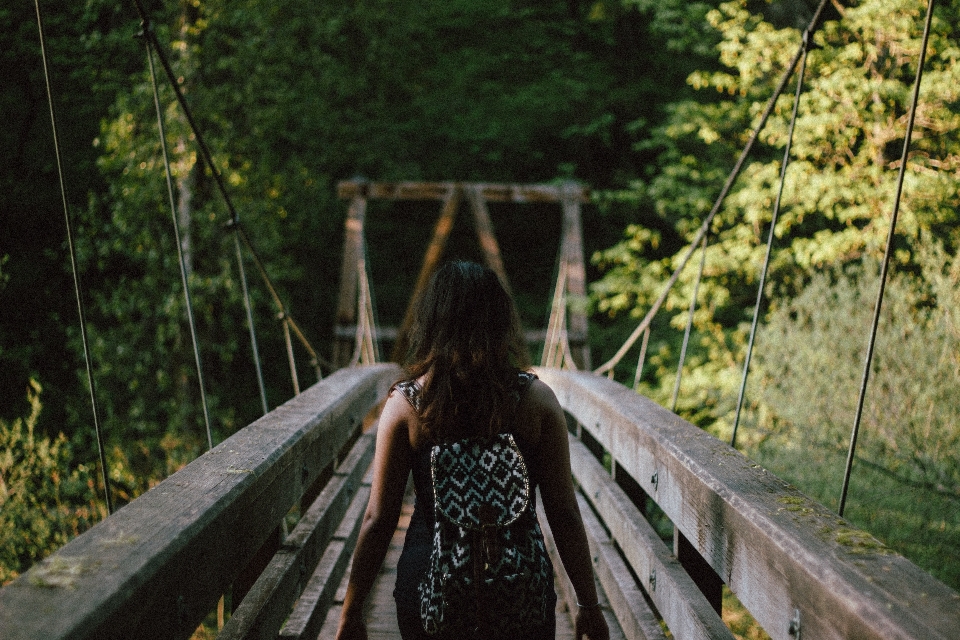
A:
[405,261,529,441]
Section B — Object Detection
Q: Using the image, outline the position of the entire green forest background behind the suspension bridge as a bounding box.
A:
[0,0,960,624]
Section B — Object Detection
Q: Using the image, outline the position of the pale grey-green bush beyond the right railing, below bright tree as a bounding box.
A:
[752,240,960,500]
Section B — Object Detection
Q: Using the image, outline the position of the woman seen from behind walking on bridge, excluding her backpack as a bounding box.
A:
[337,262,609,640]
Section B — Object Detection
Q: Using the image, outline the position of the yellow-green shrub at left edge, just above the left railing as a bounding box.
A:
[0,381,105,585]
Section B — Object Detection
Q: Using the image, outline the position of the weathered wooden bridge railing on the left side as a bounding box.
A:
[0,365,399,640]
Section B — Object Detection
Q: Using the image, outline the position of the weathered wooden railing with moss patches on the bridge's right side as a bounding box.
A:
[537,369,960,640]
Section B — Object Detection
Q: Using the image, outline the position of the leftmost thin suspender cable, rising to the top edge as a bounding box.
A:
[34,0,113,514]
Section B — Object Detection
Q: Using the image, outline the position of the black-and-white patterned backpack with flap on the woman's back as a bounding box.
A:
[419,373,553,638]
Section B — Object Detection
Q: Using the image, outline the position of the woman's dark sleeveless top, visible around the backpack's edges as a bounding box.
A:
[393,371,553,640]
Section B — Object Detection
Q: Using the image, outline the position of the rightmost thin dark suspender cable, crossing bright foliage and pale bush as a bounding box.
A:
[837,0,934,517]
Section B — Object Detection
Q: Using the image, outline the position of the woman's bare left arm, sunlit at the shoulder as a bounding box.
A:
[337,393,415,640]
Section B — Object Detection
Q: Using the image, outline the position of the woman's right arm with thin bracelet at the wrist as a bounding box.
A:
[529,380,610,640]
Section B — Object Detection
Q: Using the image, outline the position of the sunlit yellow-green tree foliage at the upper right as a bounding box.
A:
[593,0,960,424]
